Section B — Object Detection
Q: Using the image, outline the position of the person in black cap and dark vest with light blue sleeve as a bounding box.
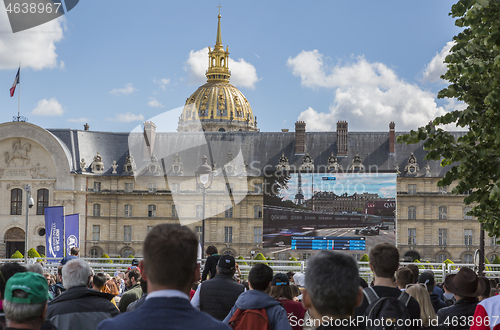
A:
[191,255,245,321]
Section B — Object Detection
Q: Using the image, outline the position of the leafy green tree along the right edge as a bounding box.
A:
[398,0,500,236]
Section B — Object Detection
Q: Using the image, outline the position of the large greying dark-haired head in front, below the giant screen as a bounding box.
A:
[302,251,363,319]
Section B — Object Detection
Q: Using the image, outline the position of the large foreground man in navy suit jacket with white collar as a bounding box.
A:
[97,224,229,330]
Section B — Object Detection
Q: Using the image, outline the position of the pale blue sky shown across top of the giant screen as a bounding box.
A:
[280,173,396,201]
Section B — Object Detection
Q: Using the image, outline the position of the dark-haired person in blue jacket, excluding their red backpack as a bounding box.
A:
[222,264,291,330]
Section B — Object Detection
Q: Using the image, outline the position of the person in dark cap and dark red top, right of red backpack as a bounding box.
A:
[269,273,306,330]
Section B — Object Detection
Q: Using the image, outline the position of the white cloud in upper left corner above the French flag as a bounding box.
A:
[0,5,66,70]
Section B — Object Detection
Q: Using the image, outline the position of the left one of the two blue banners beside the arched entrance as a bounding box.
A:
[45,206,64,258]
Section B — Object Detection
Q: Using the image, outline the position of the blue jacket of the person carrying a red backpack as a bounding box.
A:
[222,290,292,330]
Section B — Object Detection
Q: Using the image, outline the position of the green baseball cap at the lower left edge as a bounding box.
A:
[5,272,49,304]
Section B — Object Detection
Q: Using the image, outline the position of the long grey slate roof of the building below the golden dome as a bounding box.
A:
[49,129,463,177]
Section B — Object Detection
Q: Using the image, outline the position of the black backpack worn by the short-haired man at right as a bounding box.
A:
[363,287,412,330]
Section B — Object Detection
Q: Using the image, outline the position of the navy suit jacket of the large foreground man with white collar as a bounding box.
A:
[97,297,231,330]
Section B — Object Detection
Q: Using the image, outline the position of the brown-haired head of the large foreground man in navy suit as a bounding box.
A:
[139,224,200,294]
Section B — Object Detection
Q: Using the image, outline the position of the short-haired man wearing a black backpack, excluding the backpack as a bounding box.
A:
[354,243,420,329]
